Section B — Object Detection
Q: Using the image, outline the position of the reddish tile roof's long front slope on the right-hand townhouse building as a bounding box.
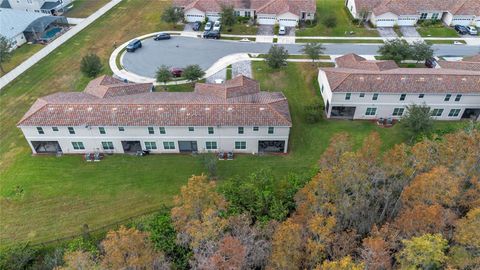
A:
[321,53,480,94]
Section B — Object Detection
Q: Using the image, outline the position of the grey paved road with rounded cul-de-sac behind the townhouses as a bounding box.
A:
[123,36,479,78]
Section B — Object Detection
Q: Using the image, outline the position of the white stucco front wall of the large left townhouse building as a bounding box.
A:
[20,126,290,154]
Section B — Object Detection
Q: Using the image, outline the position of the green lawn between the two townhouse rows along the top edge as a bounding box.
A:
[296,0,378,37]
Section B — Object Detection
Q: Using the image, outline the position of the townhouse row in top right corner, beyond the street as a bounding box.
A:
[345,0,480,27]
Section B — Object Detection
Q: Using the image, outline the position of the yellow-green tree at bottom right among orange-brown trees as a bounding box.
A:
[397,234,448,269]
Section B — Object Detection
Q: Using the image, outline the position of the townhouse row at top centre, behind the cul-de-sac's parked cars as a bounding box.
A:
[173,0,316,27]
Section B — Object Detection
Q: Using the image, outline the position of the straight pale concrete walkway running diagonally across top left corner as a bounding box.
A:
[0,0,122,89]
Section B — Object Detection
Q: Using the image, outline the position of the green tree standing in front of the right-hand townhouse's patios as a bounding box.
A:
[400,104,433,139]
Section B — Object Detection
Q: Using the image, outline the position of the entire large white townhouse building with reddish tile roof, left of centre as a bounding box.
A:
[18,76,291,154]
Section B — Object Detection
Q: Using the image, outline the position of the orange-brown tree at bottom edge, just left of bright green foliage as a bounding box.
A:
[102,226,163,269]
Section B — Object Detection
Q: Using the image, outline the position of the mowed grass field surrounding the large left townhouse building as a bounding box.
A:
[0,0,461,246]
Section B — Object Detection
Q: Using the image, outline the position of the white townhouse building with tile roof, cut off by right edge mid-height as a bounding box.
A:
[318,54,480,121]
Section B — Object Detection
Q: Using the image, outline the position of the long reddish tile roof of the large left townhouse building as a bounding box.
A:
[18,76,292,126]
